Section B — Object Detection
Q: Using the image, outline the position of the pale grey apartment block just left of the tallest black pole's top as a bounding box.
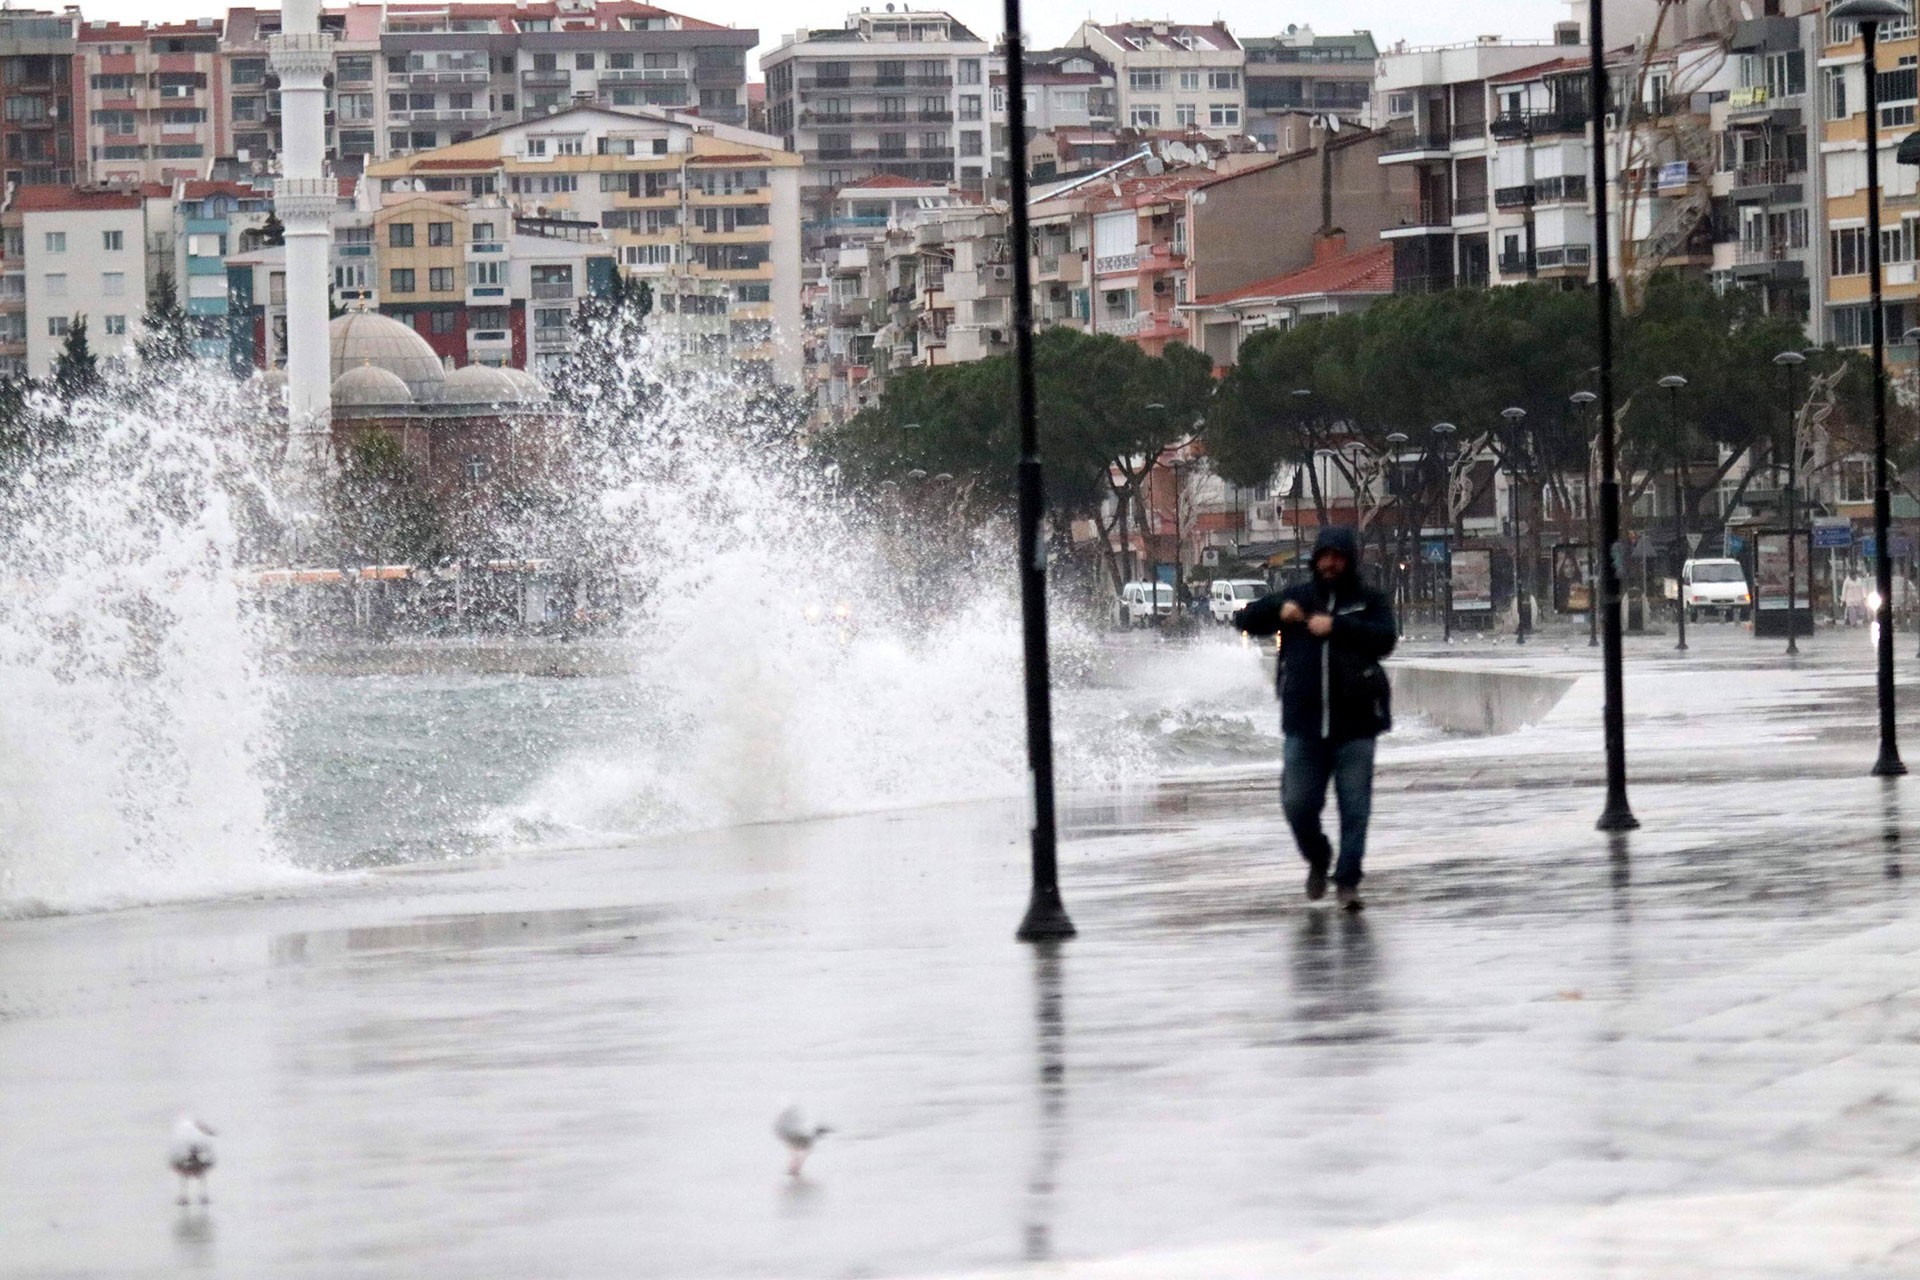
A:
[760,10,993,217]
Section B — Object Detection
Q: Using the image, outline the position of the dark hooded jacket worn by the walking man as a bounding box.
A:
[1233,528,1398,743]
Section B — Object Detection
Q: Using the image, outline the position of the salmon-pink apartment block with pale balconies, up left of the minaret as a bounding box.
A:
[79,17,225,184]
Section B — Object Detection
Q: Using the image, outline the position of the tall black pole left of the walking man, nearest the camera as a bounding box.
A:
[1006,0,1082,942]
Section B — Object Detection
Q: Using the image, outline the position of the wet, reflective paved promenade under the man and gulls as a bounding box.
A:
[0,628,1920,1278]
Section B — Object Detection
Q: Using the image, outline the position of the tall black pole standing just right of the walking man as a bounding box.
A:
[1586,0,1640,831]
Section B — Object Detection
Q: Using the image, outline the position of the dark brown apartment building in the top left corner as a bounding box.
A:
[0,10,84,186]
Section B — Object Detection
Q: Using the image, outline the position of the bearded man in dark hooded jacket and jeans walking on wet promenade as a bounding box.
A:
[1233,528,1396,912]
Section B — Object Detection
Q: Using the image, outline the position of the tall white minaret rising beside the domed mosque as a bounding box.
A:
[269,0,338,434]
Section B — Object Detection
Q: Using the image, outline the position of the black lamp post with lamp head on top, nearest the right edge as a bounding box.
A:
[1827,0,1908,777]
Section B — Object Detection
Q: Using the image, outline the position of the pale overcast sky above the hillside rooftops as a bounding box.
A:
[71,0,1567,70]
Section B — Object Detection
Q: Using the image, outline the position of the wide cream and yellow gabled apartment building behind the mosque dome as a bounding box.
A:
[367,107,803,382]
